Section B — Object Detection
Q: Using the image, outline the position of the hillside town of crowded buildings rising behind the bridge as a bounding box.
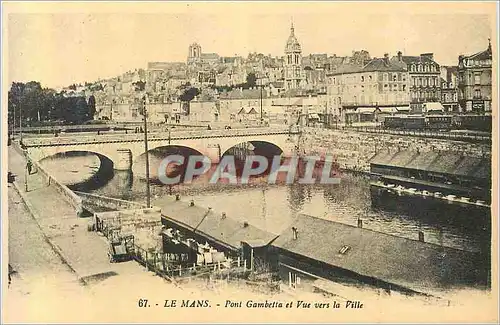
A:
[58,24,492,126]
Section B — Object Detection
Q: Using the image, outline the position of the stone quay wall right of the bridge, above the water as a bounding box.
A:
[299,128,491,172]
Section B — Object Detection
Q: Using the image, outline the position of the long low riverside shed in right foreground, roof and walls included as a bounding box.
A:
[269,214,489,294]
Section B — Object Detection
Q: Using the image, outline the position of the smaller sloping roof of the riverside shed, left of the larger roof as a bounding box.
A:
[156,198,277,248]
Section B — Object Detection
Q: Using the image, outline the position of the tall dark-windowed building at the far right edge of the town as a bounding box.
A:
[458,42,492,113]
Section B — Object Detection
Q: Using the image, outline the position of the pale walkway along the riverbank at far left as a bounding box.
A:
[8,146,112,281]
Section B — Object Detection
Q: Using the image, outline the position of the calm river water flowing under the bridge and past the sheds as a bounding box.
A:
[43,155,491,251]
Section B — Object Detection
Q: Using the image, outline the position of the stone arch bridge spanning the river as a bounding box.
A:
[23,127,301,170]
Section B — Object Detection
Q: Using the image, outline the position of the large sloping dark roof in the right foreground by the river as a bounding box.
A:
[272,214,486,292]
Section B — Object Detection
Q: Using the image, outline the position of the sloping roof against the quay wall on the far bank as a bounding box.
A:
[370,151,491,181]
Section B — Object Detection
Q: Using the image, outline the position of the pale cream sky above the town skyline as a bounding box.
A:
[2,2,496,87]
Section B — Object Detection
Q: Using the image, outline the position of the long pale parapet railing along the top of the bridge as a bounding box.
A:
[23,128,301,147]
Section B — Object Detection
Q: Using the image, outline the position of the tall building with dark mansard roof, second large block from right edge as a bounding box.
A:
[392,52,441,113]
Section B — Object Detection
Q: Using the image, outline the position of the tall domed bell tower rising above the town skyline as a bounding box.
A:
[284,24,305,89]
